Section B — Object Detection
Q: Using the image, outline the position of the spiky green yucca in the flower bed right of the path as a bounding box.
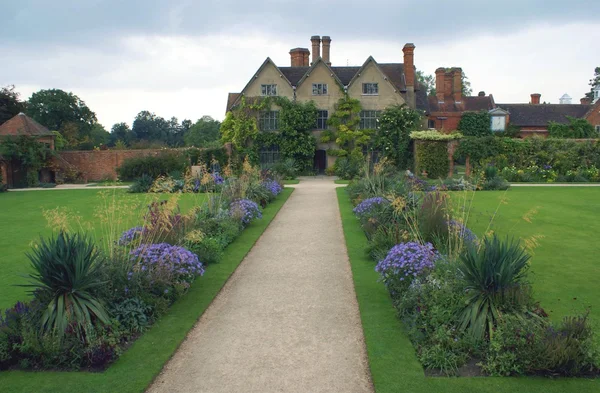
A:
[459,235,530,339]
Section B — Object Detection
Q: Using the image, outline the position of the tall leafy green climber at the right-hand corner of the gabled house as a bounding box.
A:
[375,104,421,169]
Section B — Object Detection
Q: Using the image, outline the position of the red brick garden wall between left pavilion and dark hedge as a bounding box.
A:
[54,149,164,181]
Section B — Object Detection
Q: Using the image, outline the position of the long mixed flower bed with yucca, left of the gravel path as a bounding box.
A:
[0,160,286,370]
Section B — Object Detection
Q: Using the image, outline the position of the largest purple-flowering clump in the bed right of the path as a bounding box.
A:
[375,242,436,297]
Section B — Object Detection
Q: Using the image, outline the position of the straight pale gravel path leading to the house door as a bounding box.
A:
[148,178,373,393]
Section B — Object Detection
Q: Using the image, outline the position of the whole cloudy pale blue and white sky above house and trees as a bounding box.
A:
[0,0,600,129]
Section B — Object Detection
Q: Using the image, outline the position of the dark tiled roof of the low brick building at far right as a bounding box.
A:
[496,104,591,127]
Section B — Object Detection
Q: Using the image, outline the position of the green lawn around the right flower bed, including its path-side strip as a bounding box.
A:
[337,187,600,393]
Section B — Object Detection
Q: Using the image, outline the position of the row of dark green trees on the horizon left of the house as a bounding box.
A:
[0,86,221,150]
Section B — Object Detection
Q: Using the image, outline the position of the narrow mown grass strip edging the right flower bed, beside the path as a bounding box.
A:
[337,188,600,393]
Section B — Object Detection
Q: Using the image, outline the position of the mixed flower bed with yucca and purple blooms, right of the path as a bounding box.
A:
[347,163,600,376]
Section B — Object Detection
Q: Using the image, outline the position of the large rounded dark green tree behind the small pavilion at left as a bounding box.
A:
[26,89,97,139]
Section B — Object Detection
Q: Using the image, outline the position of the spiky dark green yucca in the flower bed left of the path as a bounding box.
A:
[23,231,109,337]
